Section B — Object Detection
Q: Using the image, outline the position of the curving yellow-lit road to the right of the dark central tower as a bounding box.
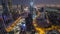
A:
[33,12,60,34]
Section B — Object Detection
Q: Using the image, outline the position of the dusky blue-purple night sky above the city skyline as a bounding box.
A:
[0,0,60,5]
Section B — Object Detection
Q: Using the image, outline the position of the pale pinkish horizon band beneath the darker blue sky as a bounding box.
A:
[0,4,60,8]
